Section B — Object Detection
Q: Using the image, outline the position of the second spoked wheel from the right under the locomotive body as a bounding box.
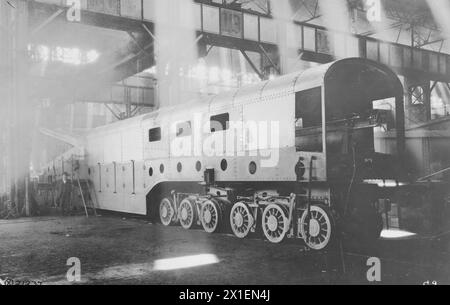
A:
[261,204,288,244]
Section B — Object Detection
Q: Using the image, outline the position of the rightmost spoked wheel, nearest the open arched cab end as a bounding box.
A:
[300,205,334,250]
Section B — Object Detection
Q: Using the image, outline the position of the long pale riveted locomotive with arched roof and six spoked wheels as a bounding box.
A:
[44,58,407,250]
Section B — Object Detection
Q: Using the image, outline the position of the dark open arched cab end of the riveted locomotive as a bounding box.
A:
[296,59,406,242]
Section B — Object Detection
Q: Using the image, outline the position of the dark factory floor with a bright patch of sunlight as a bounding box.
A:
[0,215,450,285]
